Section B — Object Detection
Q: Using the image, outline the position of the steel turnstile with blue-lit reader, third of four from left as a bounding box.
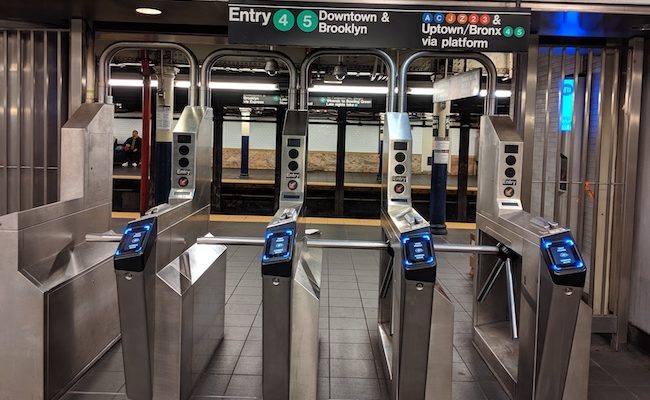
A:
[378,113,454,400]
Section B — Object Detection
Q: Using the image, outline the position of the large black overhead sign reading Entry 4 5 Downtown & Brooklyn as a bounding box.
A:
[228,0,531,52]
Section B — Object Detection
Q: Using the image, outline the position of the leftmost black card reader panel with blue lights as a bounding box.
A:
[113,217,157,272]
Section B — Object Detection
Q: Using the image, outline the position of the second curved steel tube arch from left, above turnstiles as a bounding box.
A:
[199,49,298,110]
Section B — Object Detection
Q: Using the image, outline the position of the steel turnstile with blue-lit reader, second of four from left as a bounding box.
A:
[262,110,322,400]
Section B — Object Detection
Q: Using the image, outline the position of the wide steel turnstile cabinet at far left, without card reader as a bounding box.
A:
[0,104,119,399]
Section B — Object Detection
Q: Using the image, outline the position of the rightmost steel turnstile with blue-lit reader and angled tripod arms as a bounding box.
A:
[473,116,591,400]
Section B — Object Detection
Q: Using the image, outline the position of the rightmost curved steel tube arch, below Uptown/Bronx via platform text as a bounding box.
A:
[399,50,497,115]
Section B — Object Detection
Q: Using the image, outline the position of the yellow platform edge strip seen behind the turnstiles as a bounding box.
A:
[113,211,476,230]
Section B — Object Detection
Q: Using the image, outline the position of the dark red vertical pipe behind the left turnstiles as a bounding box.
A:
[140,50,151,215]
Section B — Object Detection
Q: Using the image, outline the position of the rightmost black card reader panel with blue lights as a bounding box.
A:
[540,232,587,287]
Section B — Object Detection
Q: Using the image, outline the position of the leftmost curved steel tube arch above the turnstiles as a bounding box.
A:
[97,42,199,106]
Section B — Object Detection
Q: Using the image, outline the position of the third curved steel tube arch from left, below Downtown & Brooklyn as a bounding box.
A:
[300,49,397,112]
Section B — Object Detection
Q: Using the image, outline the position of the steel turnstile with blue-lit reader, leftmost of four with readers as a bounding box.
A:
[110,107,226,400]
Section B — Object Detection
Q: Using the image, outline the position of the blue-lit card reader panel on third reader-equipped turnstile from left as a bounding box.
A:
[401,230,436,282]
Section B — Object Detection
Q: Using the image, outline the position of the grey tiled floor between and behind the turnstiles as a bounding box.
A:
[65,223,650,400]
